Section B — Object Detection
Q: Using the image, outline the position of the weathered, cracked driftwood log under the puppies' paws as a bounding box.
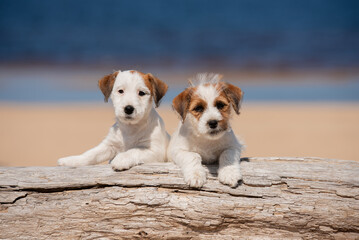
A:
[0,158,359,239]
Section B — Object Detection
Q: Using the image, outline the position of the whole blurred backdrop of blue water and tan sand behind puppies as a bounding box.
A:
[0,0,359,166]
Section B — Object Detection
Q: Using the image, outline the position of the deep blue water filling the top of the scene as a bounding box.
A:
[0,0,359,69]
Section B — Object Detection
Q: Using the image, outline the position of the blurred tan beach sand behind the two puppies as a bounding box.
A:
[0,103,359,166]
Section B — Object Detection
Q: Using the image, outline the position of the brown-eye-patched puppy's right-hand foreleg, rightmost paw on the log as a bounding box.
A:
[218,149,242,187]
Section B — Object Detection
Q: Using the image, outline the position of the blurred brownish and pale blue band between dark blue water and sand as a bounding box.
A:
[0,64,359,104]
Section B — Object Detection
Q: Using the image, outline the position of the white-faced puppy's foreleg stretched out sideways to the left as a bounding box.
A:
[57,141,116,167]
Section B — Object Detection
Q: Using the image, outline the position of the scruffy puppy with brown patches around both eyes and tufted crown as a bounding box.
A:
[167,74,243,188]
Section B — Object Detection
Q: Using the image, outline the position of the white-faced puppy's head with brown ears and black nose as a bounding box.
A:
[99,70,168,124]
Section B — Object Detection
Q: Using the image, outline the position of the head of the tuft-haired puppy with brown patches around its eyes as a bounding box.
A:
[173,75,243,139]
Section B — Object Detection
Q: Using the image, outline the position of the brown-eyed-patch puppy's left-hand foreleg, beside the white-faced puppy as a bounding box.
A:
[172,150,207,188]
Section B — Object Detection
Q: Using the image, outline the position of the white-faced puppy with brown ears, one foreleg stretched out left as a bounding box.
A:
[58,71,169,170]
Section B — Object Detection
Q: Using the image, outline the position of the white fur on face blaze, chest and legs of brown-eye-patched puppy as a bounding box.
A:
[167,76,242,188]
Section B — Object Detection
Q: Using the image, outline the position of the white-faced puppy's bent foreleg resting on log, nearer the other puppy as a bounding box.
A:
[111,148,162,171]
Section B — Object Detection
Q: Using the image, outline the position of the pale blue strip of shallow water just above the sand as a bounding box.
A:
[0,74,359,104]
